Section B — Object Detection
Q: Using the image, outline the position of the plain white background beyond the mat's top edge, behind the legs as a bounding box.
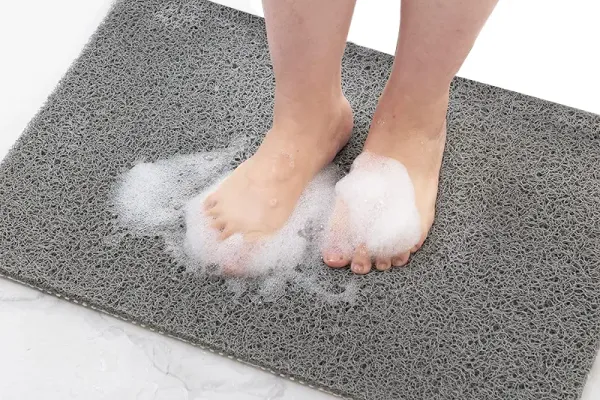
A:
[0,0,600,162]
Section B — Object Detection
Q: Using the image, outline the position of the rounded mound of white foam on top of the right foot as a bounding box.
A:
[324,152,421,257]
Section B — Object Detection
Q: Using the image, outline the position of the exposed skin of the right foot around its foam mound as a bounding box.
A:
[323,92,447,274]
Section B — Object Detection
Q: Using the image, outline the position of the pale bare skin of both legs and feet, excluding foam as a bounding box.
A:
[205,0,497,274]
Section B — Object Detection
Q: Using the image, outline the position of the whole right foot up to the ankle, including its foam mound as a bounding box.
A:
[323,91,448,274]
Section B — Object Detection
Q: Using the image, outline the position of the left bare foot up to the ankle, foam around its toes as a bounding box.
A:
[204,96,353,242]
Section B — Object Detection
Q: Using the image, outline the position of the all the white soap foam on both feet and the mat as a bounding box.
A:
[111,149,421,302]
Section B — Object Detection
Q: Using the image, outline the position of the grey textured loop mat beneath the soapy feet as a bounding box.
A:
[0,0,600,399]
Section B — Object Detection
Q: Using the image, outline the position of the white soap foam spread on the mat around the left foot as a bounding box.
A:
[111,150,356,302]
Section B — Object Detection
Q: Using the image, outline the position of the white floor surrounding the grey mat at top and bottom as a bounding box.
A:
[0,0,600,400]
